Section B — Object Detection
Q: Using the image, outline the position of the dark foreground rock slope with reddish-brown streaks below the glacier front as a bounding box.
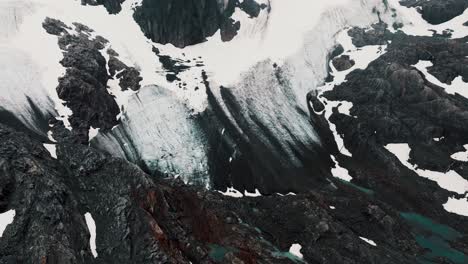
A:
[0,122,422,264]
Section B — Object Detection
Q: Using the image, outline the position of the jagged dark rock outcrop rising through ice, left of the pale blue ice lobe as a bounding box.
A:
[43,18,142,144]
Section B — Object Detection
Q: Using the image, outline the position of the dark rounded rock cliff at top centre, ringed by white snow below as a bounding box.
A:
[133,0,266,47]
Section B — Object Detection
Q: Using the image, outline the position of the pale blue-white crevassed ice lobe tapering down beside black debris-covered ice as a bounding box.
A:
[95,86,209,184]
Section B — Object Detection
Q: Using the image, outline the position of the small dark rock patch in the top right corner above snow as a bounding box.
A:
[400,0,468,25]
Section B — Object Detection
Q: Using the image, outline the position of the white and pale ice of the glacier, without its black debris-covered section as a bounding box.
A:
[0,0,392,188]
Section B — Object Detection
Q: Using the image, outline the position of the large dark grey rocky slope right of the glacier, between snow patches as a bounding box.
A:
[312,24,468,263]
